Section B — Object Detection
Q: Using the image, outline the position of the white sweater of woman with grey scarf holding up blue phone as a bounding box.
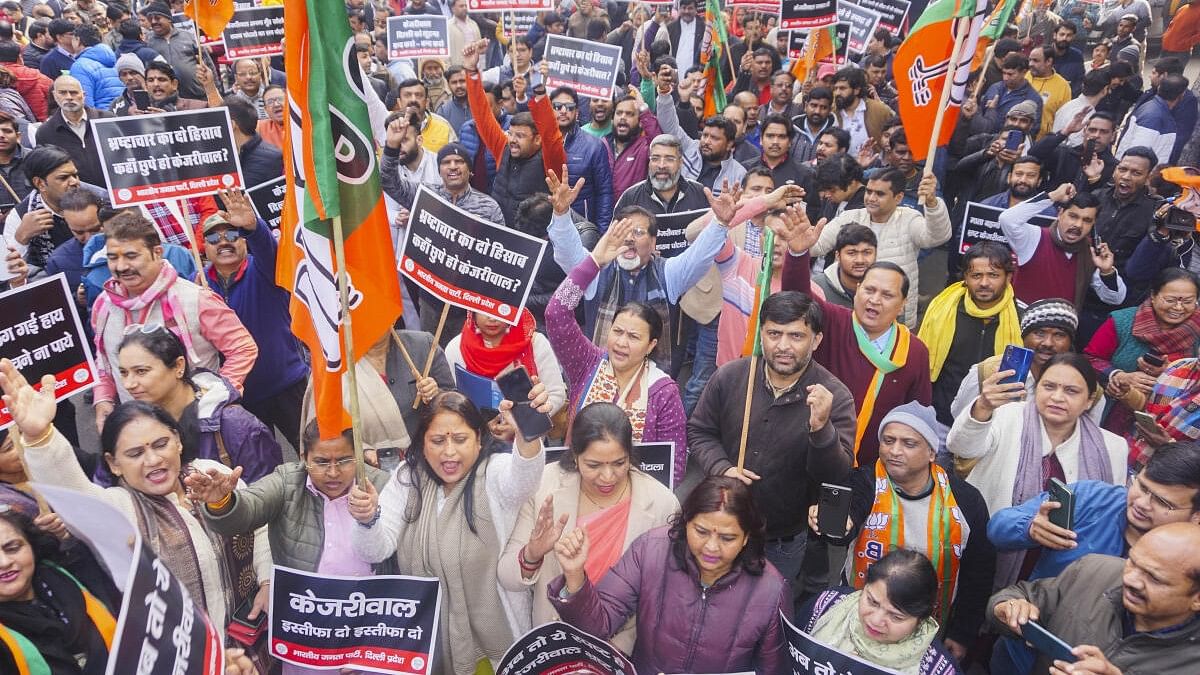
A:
[946,400,1129,513]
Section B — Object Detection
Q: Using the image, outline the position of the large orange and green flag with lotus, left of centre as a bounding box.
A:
[276,0,401,438]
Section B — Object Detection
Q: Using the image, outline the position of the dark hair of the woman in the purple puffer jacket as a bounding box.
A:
[667,476,767,577]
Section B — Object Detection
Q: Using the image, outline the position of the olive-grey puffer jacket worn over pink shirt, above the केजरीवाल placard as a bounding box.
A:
[200,461,394,574]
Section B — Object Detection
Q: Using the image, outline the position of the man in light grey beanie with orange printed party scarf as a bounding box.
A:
[809,401,996,663]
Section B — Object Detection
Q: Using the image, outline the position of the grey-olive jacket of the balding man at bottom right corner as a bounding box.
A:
[986,554,1200,675]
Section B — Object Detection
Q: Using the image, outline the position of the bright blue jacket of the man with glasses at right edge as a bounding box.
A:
[988,480,1127,581]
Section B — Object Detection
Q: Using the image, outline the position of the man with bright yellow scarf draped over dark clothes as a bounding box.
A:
[917,240,1021,425]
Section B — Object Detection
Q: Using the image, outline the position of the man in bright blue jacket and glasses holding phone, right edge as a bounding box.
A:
[988,442,1200,673]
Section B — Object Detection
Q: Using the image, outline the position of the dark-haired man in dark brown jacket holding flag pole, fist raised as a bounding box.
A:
[688,289,854,584]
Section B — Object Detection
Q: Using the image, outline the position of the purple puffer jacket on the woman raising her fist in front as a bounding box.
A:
[547,527,792,674]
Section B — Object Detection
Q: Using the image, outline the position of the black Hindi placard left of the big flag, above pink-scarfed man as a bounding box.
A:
[91,107,242,207]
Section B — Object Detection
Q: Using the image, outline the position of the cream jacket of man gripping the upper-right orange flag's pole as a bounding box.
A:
[812,198,953,329]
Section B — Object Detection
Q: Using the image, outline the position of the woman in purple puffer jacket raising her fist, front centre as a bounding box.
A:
[547,476,792,675]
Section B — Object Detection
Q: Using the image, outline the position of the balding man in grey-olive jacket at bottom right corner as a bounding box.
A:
[988,522,1200,675]
